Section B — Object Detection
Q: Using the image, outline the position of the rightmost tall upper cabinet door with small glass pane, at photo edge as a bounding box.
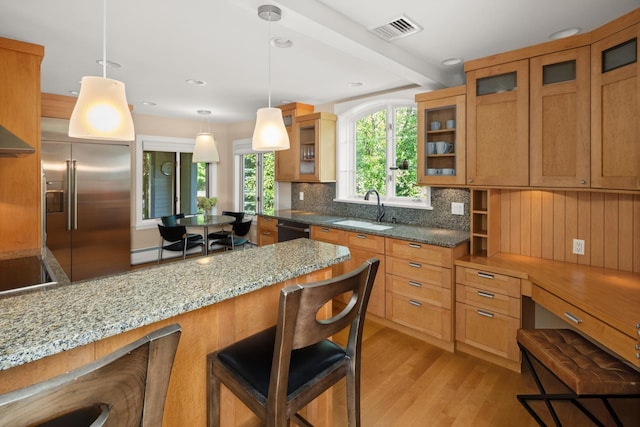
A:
[591,24,640,190]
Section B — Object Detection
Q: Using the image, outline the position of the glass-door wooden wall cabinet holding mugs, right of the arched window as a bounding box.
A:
[416,86,466,185]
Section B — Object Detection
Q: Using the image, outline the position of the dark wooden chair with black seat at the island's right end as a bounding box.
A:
[207,258,380,427]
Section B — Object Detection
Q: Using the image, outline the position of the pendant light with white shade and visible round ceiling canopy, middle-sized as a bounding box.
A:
[252,5,289,151]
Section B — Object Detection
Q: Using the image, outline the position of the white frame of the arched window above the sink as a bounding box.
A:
[334,96,433,210]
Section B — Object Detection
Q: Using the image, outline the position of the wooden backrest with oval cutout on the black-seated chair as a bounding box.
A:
[269,258,380,399]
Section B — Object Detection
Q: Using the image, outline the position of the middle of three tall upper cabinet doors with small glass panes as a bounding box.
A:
[530,46,591,188]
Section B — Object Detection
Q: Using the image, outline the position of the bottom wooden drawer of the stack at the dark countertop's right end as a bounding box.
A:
[386,292,452,341]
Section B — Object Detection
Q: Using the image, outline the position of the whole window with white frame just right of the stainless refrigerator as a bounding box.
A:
[136,136,215,228]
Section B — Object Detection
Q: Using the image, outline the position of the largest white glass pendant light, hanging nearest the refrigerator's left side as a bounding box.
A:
[69,0,135,141]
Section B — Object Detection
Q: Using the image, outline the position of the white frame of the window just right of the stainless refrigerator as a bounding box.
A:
[135,135,217,230]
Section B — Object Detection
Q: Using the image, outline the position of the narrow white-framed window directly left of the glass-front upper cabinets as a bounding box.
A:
[233,139,275,215]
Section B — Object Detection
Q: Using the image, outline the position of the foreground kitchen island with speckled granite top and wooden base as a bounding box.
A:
[0,239,349,426]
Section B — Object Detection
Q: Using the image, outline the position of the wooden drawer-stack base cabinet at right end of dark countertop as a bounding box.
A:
[385,238,466,350]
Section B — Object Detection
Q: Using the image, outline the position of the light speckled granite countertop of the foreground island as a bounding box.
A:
[0,239,350,370]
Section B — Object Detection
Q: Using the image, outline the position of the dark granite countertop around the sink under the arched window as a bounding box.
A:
[261,210,469,248]
